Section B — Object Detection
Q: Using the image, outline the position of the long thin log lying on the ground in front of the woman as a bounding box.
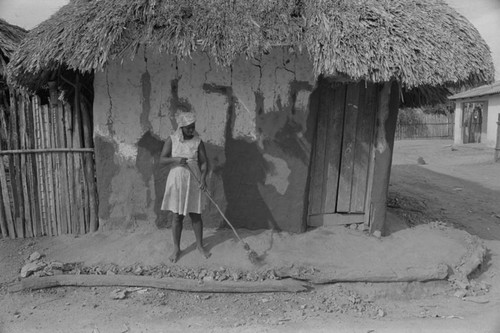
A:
[8,275,308,293]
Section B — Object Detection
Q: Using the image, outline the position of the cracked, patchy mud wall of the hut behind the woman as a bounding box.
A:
[94,49,315,232]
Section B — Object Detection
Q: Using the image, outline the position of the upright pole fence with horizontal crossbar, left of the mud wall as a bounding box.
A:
[0,91,97,238]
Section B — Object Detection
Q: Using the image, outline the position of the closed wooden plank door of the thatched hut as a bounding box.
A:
[308,81,376,226]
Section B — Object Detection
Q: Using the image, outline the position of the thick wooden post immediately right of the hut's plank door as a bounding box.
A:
[370,81,399,235]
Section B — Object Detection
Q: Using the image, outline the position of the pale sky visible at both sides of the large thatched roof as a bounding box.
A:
[0,0,500,80]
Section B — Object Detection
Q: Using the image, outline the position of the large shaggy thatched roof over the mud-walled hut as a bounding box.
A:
[9,0,494,89]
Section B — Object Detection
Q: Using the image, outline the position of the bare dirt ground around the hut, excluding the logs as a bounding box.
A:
[0,140,500,333]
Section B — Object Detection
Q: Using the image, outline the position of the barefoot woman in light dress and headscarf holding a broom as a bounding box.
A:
[160,112,210,263]
